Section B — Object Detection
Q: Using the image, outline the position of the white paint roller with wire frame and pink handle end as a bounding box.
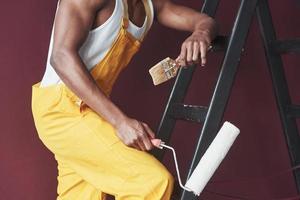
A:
[152,121,240,196]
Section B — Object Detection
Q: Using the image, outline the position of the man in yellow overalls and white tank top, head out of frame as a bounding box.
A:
[32,0,217,200]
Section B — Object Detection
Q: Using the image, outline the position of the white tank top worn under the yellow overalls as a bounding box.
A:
[40,0,154,87]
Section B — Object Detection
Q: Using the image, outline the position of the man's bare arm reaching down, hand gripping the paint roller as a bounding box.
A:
[51,0,154,150]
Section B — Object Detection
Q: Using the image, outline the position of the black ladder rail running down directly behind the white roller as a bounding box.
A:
[181,0,257,200]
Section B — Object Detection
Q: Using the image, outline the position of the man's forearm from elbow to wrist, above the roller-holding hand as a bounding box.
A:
[51,51,126,126]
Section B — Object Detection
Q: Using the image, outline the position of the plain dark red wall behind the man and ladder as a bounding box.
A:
[0,0,300,200]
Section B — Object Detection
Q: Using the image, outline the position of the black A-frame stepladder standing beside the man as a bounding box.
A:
[153,0,300,200]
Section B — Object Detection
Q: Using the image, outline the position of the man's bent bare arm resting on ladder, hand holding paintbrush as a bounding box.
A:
[153,0,218,65]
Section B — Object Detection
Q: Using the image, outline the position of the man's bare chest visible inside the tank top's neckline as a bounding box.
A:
[93,0,146,28]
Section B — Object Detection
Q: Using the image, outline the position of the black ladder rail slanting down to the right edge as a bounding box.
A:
[257,0,300,192]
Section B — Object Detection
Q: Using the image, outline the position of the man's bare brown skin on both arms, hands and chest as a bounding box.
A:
[50,0,217,151]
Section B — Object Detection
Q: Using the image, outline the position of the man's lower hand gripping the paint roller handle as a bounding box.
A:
[116,118,155,151]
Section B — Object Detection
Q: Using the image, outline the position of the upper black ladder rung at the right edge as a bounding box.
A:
[272,38,300,54]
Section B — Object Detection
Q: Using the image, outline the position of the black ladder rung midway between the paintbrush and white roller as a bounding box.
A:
[168,104,207,123]
